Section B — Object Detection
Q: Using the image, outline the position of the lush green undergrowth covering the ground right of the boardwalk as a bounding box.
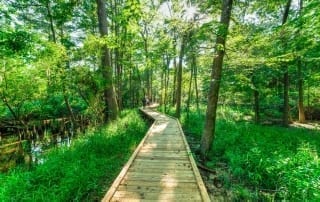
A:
[165,107,320,201]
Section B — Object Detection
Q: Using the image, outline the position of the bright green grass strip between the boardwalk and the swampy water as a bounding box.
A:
[0,111,147,201]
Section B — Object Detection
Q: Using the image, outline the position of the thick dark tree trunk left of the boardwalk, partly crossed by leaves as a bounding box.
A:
[96,0,119,121]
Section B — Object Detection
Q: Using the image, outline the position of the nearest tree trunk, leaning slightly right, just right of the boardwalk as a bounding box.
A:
[200,0,233,160]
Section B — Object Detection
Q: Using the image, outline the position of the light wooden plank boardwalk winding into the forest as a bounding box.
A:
[102,108,210,201]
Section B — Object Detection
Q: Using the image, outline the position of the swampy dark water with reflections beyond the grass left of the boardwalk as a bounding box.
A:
[0,123,85,172]
